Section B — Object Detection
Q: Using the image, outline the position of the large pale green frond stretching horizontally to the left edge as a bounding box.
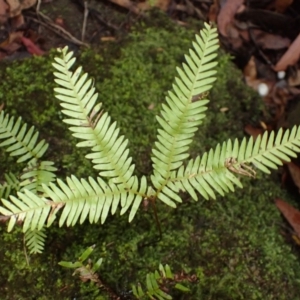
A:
[0,176,147,232]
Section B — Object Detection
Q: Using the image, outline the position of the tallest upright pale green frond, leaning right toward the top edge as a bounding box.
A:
[151,24,219,201]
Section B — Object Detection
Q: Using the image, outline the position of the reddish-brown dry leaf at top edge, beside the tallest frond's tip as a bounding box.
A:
[217,0,244,36]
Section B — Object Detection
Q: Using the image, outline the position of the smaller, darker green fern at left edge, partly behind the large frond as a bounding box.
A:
[0,110,56,253]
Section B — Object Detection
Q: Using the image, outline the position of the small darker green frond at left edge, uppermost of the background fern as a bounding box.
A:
[0,111,48,163]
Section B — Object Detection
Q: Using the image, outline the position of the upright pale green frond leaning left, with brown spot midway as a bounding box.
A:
[53,47,135,188]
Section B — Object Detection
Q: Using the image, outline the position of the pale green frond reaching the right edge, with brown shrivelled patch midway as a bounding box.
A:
[161,126,300,206]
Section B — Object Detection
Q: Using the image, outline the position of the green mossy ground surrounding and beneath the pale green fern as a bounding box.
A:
[0,11,300,299]
